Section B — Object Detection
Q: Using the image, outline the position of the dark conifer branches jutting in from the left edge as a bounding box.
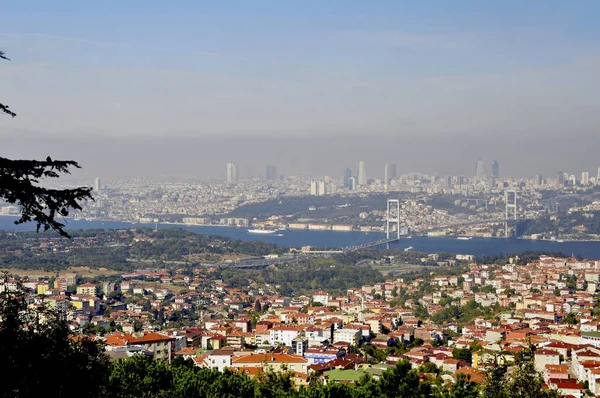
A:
[0,51,93,237]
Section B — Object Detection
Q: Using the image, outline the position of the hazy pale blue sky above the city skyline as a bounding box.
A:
[0,0,600,178]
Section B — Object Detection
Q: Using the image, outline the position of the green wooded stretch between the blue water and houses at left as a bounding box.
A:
[0,228,285,271]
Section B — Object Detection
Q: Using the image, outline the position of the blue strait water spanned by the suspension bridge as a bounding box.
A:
[0,217,600,260]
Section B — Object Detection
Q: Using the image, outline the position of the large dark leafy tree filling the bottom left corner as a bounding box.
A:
[0,274,108,397]
